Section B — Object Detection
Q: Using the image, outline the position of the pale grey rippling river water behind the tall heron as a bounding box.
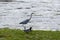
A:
[0,0,60,31]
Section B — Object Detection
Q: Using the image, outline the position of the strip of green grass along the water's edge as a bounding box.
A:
[0,28,60,40]
